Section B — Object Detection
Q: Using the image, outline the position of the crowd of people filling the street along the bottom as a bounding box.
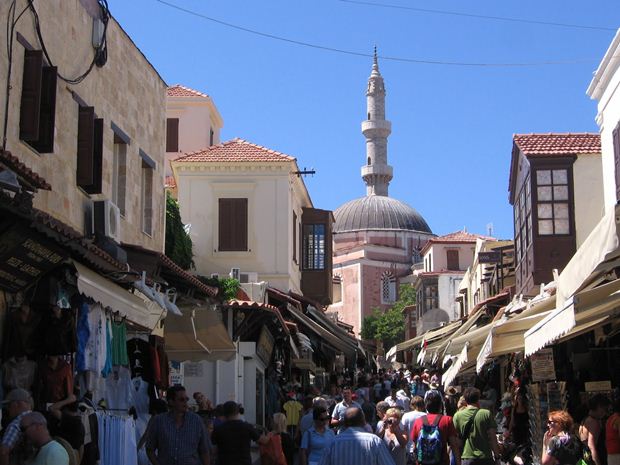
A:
[0,364,620,465]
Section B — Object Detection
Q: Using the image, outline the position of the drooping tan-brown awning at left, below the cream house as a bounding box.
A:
[164,307,236,362]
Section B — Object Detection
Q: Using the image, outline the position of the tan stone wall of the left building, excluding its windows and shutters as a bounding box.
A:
[0,0,166,251]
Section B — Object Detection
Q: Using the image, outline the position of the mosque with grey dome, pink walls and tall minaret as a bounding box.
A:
[328,53,433,334]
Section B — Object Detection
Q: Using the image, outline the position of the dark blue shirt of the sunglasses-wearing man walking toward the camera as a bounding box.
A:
[146,412,211,465]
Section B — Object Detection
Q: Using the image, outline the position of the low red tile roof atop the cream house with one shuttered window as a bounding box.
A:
[173,138,295,163]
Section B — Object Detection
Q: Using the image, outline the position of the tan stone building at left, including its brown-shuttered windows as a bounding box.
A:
[0,0,166,251]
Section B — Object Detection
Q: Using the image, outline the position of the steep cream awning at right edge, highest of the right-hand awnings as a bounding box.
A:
[557,205,620,307]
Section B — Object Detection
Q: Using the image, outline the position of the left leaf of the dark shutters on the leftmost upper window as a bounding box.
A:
[19,50,43,141]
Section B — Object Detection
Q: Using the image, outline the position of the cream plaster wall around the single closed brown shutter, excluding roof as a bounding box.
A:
[175,162,310,292]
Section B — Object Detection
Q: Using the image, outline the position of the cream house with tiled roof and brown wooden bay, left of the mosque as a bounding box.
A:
[172,139,331,298]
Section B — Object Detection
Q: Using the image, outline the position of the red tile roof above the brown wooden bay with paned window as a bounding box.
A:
[513,132,601,156]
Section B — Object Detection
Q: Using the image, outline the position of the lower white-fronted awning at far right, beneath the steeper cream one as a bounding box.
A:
[525,279,620,356]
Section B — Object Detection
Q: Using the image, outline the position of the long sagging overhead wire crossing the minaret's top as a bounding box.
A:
[155,0,595,68]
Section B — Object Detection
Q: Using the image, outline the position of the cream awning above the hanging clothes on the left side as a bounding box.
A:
[73,261,164,330]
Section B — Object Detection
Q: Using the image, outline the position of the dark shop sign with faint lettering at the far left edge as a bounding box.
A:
[0,224,67,292]
